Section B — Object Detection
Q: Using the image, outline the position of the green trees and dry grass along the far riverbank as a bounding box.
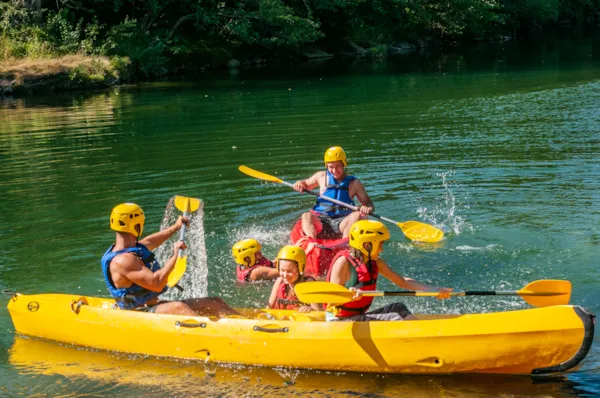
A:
[0,0,600,92]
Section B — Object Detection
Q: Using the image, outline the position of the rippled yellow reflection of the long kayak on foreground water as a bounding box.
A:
[0,337,588,397]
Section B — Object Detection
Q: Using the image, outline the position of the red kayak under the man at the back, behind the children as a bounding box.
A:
[290,220,348,278]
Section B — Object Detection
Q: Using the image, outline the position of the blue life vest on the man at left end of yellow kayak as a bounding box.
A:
[100,243,168,310]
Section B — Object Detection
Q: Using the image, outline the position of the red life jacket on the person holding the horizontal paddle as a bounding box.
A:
[327,250,379,318]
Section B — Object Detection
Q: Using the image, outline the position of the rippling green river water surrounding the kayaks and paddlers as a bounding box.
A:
[0,39,600,397]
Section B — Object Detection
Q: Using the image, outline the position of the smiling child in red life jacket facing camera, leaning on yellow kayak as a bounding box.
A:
[269,246,319,312]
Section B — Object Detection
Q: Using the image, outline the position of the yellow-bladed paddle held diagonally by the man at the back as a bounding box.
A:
[238,165,444,243]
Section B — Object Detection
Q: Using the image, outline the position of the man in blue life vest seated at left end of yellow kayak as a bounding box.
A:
[101,203,239,317]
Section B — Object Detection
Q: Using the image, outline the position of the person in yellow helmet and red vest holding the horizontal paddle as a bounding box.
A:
[326,220,452,321]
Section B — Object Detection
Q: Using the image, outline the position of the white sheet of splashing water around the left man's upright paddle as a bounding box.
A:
[156,198,208,300]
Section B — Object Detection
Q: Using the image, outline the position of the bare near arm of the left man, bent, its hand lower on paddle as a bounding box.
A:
[110,242,186,292]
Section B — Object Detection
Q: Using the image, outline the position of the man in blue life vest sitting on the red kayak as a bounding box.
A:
[294,146,375,239]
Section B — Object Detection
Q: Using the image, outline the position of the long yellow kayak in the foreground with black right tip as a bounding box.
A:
[8,293,594,374]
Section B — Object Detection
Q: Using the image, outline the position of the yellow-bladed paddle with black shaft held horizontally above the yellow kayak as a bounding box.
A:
[294,279,571,307]
